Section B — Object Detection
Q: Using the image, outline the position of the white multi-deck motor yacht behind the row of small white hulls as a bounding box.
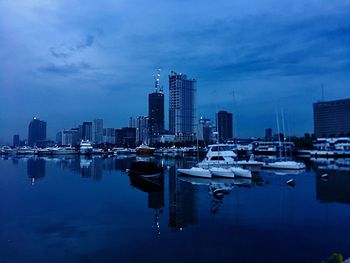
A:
[197,144,237,169]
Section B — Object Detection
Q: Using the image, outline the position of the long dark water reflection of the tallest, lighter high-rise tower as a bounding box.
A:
[169,167,198,231]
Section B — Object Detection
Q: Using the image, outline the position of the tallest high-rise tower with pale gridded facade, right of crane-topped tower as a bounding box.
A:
[169,71,196,141]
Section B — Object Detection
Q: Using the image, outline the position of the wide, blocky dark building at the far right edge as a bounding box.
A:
[313,99,350,137]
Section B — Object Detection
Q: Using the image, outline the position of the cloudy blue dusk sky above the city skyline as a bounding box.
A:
[0,0,350,143]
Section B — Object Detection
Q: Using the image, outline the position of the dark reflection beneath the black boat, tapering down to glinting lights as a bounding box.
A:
[129,173,164,235]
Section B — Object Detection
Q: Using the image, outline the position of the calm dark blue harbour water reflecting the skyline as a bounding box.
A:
[0,156,350,262]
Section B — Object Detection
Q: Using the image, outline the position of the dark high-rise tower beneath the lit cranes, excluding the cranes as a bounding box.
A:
[148,90,164,137]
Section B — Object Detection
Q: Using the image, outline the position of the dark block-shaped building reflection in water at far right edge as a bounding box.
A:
[316,167,350,204]
